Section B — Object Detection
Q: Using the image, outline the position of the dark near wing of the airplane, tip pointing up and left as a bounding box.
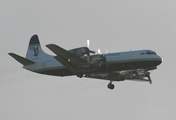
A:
[46,44,88,74]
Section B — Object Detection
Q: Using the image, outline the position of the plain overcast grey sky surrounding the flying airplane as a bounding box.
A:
[0,0,176,120]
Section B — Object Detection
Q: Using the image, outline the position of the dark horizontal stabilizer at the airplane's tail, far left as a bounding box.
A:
[8,53,35,65]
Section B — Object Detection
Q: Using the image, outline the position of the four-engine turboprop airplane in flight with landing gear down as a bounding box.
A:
[9,35,162,89]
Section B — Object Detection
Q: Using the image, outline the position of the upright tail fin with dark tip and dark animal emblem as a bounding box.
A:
[26,35,48,61]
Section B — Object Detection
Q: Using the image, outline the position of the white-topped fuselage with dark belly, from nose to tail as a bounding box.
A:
[24,50,162,76]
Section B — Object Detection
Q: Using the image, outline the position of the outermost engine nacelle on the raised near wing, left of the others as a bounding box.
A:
[69,47,89,57]
